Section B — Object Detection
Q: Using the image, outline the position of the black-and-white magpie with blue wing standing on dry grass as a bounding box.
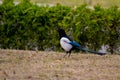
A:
[57,28,106,58]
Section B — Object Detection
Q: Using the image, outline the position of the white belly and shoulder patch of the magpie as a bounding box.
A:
[60,37,72,51]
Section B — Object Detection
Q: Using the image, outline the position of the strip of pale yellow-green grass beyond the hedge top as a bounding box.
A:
[31,0,120,7]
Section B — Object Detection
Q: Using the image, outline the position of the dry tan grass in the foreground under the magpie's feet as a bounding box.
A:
[0,50,120,80]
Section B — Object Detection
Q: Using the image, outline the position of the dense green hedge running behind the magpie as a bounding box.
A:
[0,0,120,53]
